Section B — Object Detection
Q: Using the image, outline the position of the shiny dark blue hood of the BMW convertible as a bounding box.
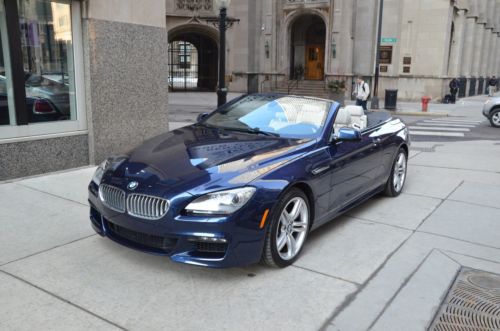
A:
[112,125,316,194]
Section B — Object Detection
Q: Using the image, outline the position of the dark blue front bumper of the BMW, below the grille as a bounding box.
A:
[89,183,272,268]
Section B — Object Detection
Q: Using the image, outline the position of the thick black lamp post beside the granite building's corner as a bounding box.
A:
[204,0,240,107]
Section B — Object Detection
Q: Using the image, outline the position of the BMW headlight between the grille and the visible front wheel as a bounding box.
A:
[186,187,255,215]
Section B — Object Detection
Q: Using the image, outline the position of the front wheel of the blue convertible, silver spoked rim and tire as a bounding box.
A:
[262,188,311,268]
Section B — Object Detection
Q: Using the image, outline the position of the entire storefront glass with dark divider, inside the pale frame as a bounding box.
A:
[0,0,79,131]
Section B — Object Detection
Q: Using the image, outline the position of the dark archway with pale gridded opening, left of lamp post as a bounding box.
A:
[168,26,218,91]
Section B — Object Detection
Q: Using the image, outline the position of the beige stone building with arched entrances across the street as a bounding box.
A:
[166,0,500,100]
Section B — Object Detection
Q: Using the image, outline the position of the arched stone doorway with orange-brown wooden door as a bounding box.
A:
[290,14,326,80]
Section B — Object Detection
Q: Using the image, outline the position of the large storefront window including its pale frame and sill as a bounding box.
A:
[0,0,86,139]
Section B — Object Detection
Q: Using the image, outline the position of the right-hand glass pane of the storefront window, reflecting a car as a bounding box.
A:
[17,0,76,123]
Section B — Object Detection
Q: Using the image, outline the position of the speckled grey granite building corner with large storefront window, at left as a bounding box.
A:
[0,0,168,181]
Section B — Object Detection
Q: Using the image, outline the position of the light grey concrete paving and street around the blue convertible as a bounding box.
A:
[0,93,500,331]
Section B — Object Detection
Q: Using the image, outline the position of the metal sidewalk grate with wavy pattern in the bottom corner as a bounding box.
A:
[429,268,500,331]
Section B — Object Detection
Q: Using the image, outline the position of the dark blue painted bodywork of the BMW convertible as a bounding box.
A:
[89,96,409,267]
